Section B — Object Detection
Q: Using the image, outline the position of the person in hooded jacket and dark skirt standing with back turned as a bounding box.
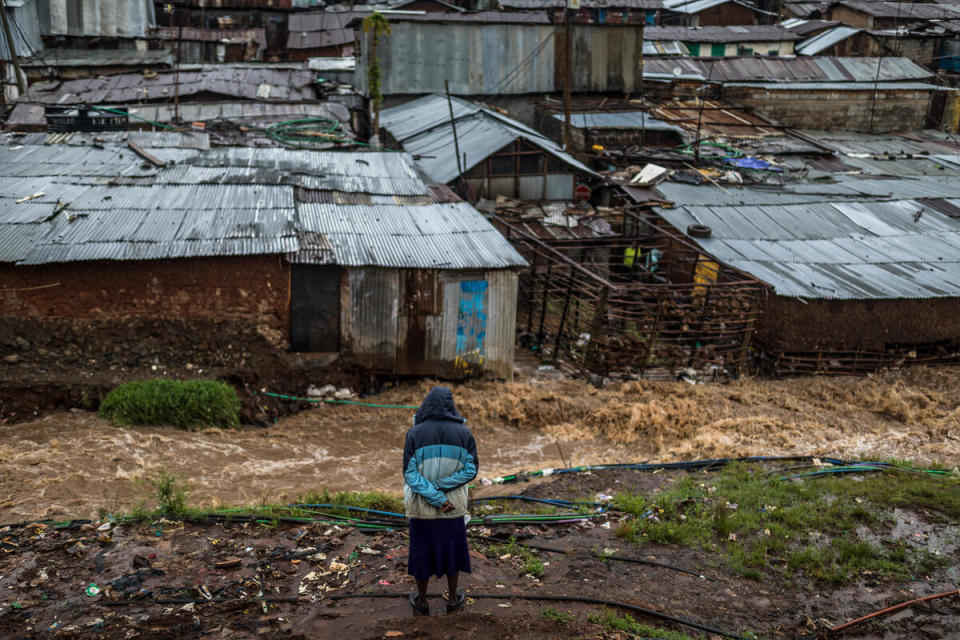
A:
[403,387,479,616]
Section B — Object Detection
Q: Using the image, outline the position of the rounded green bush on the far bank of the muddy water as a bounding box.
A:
[100,379,240,429]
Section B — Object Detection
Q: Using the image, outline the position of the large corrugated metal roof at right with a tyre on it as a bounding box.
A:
[657,175,960,299]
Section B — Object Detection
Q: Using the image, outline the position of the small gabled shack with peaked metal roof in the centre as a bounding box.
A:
[380,95,598,202]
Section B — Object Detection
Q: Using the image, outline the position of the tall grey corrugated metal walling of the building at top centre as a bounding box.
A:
[354,11,643,96]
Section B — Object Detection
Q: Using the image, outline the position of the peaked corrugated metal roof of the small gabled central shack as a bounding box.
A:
[380,95,597,184]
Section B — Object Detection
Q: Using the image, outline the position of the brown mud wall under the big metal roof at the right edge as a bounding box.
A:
[756,296,960,352]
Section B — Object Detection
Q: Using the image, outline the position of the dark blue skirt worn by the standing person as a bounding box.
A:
[407,517,470,580]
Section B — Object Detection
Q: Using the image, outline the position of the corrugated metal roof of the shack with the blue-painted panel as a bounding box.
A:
[0,141,526,269]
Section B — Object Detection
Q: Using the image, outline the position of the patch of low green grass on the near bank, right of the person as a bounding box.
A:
[616,464,960,584]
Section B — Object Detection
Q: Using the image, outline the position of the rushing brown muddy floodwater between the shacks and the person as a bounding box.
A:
[0,369,960,522]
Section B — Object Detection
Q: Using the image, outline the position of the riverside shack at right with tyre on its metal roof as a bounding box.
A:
[653,131,960,375]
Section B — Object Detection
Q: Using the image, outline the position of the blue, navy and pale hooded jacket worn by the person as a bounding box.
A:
[403,387,479,519]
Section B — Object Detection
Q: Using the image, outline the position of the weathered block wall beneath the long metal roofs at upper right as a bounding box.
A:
[723,87,931,133]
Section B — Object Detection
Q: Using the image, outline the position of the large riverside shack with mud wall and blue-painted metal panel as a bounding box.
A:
[0,132,526,377]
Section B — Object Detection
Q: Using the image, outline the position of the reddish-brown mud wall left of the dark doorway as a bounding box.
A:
[0,256,290,346]
